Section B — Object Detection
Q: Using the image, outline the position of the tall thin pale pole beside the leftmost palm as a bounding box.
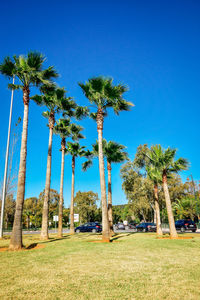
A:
[0,76,15,238]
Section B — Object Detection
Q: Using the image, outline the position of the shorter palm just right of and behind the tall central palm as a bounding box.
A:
[83,139,128,235]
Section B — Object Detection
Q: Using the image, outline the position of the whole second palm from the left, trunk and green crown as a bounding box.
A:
[32,85,76,240]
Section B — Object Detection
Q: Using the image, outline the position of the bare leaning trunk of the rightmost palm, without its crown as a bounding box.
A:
[163,174,178,239]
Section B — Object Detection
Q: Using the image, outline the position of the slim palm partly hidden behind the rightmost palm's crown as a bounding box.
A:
[146,164,163,235]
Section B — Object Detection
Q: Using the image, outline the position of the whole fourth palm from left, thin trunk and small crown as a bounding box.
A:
[66,142,89,234]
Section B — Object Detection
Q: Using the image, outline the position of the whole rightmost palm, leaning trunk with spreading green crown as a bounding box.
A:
[147,145,189,238]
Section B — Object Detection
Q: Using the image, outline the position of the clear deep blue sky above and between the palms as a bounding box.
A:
[0,0,200,205]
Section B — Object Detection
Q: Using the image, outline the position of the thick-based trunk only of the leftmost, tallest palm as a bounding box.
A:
[9,87,30,250]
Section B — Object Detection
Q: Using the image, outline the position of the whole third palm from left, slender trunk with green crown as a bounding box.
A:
[54,119,83,237]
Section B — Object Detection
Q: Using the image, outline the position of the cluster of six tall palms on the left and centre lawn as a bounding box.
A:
[0,52,132,250]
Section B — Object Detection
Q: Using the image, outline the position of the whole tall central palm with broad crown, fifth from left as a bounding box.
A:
[79,76,132,242]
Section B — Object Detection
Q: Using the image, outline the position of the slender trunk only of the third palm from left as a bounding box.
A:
[58,139,65,237]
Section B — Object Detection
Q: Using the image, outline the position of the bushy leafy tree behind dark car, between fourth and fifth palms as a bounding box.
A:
[74,191,99,224]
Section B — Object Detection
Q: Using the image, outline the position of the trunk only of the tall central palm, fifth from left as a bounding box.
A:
[97,107,110,242]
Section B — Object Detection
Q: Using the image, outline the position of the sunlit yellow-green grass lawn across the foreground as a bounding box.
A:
[0,233,200,300]
